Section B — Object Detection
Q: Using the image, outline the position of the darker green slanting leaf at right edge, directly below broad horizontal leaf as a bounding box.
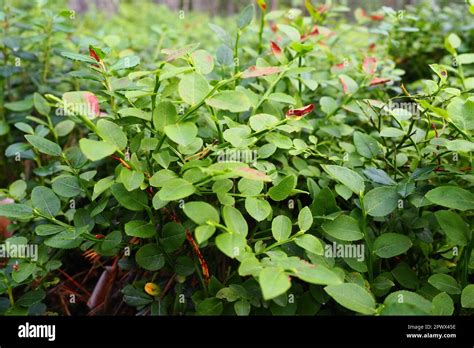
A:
[434,210,471,246]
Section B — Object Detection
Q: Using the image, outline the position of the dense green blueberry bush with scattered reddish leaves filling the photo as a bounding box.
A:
[0,0,474,315]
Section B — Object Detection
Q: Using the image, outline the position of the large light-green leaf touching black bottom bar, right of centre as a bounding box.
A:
[324,283,375,315]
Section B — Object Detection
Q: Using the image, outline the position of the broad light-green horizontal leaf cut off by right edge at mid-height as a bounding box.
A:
[425,186,474,211]
